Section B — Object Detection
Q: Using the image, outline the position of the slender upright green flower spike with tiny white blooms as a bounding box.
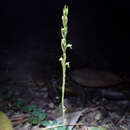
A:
[60,5,72,130]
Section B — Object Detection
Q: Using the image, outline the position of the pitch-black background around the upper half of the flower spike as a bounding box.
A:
[0,0,130,72]
